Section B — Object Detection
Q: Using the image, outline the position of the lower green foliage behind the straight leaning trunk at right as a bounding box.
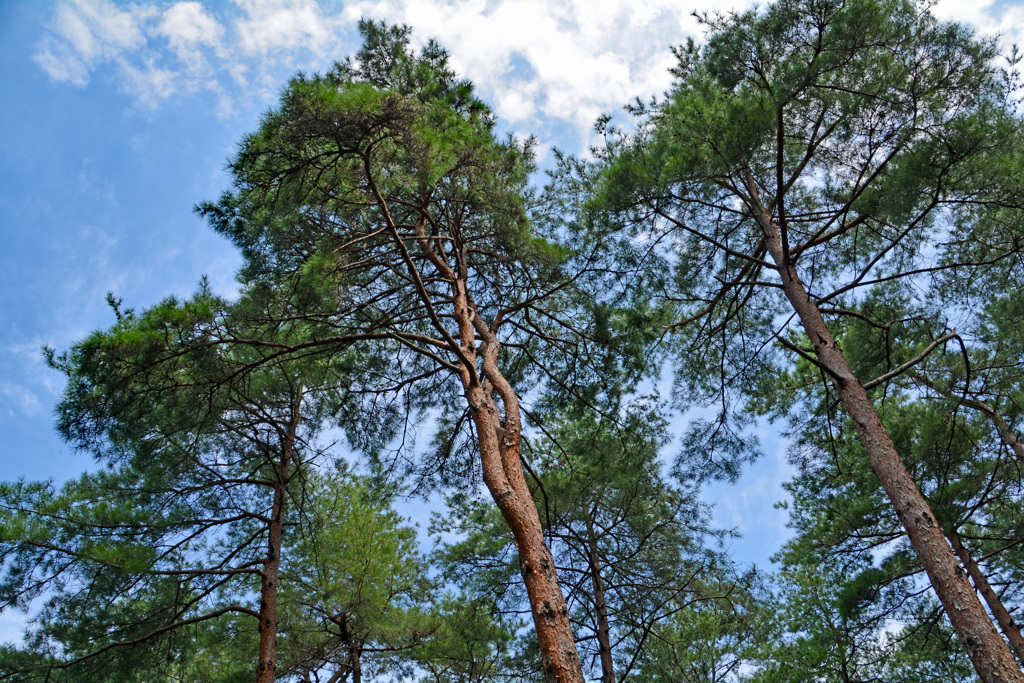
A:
[749,284,1022,681]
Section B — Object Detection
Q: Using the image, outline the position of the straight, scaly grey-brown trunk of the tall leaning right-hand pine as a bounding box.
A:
[746,180,1024,683]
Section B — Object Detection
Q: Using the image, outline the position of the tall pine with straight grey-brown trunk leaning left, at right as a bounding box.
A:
[594,0,1024,682]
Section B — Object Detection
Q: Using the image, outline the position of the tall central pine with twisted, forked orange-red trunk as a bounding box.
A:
[191,22,587,682]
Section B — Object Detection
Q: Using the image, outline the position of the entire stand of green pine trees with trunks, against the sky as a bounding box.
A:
[0,5,1024,683]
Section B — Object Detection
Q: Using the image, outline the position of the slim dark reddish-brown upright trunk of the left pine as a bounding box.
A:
[256,389,302,683]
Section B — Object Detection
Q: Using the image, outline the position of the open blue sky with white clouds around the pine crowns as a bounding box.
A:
[0,0,1024,635]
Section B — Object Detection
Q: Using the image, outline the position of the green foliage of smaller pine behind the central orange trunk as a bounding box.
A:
[432,401,760,680]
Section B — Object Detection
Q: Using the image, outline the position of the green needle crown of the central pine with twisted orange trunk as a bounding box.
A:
[189,17,625,497]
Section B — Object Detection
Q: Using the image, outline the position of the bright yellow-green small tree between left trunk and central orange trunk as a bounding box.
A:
[279,472,436,675]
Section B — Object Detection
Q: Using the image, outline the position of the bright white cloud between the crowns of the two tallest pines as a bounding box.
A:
[339,0,748,147]
